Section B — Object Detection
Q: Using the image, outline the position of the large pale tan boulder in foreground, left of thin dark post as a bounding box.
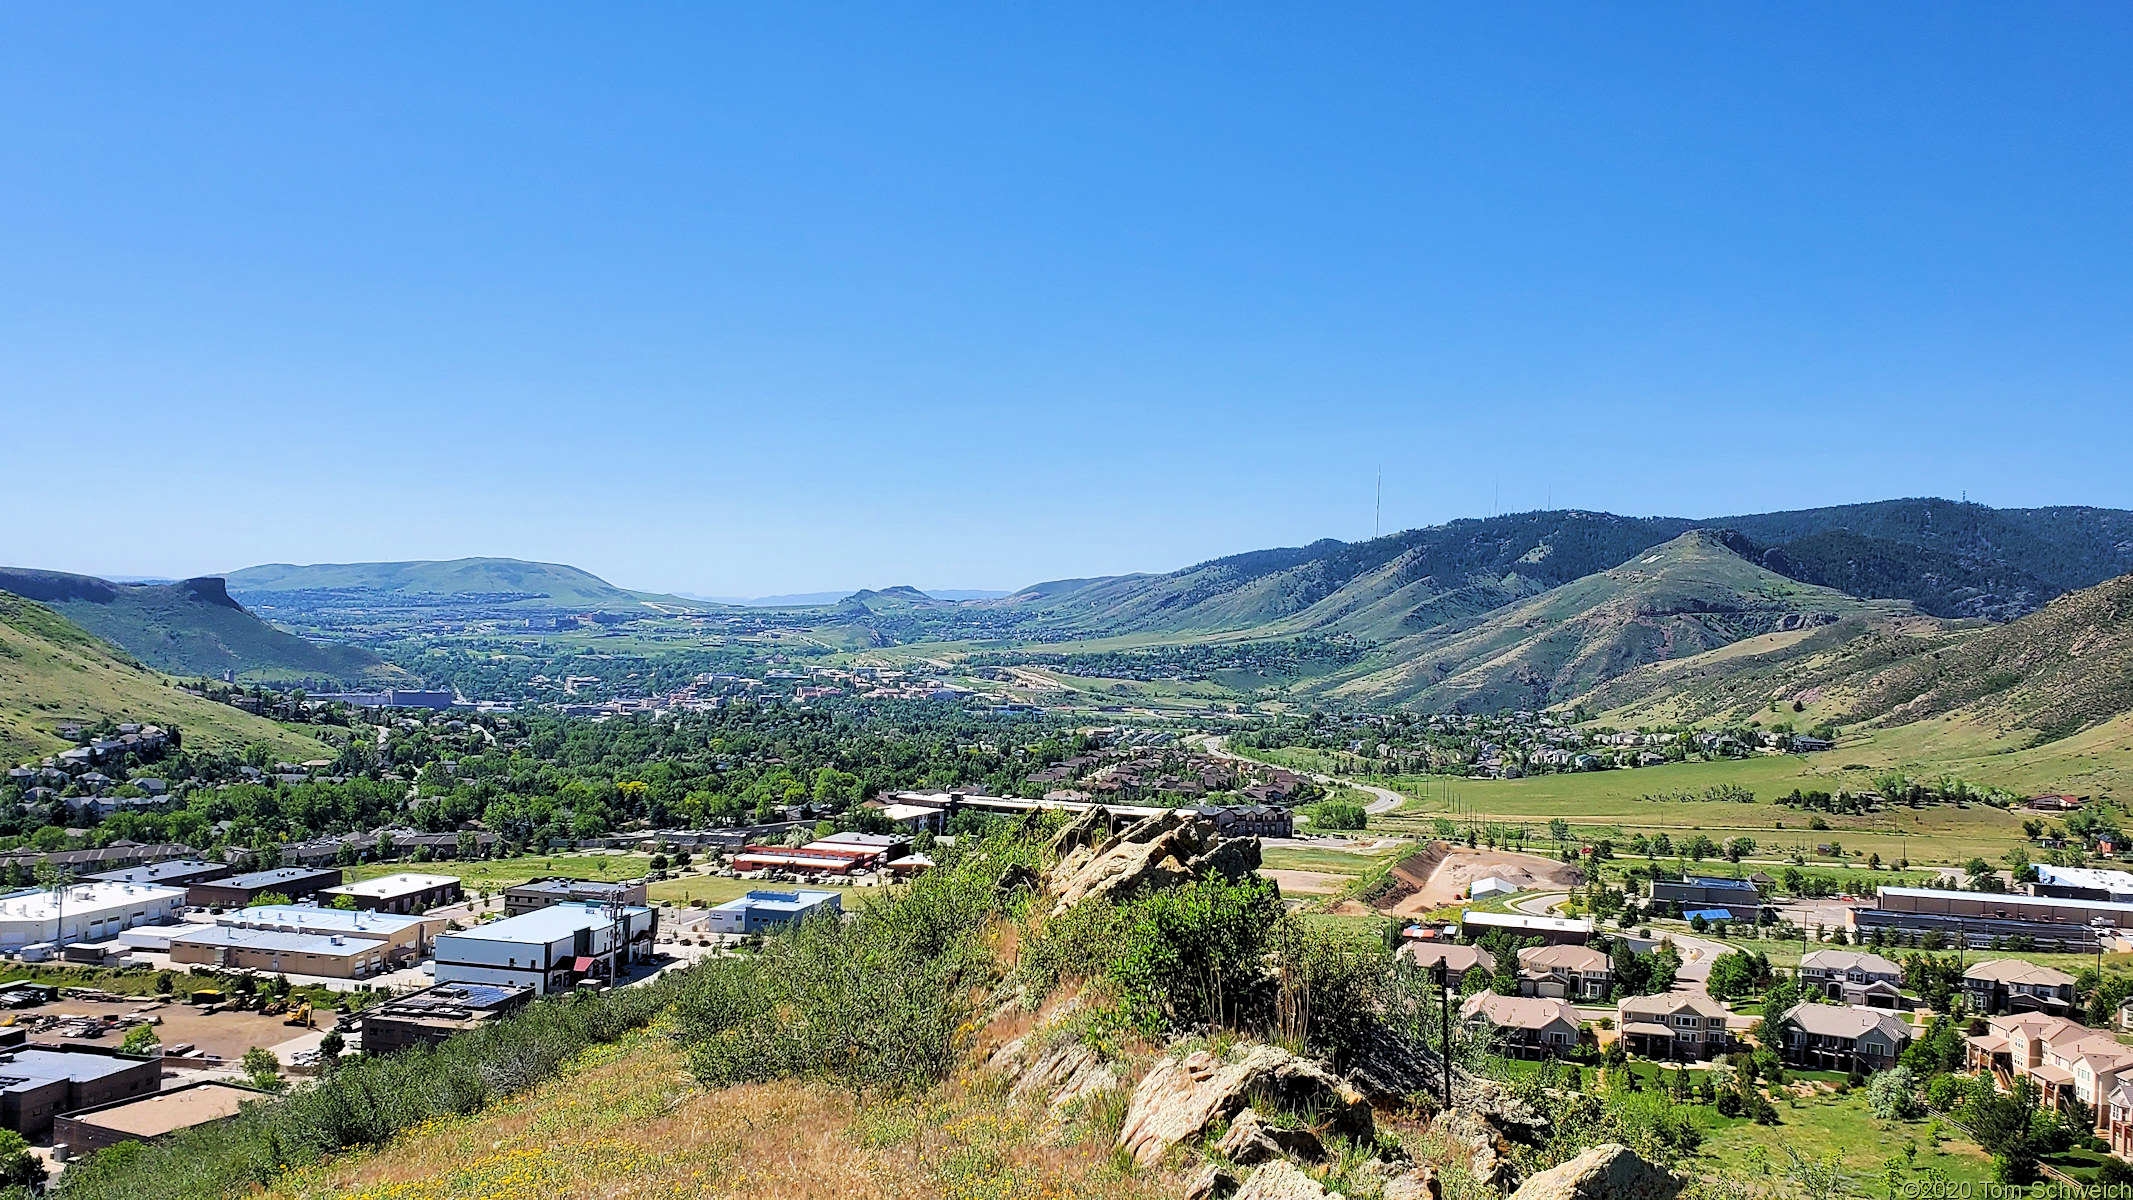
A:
[1118,1044,1376,1166]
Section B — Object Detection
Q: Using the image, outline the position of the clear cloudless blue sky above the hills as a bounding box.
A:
[0,4,2133,595]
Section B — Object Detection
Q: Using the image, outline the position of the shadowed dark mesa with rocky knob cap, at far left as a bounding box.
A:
[0,567,410,684]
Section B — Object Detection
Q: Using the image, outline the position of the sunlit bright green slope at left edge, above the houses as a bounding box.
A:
[0,593,333,763]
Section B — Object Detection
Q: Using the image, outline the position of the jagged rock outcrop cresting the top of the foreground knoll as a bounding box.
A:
[1045,808,1261,917]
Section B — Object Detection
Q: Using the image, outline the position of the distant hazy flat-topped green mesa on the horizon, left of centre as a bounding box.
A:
[226,558,715,612]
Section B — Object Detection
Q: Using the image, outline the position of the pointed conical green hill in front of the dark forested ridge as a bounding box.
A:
[1329,531,1898,712]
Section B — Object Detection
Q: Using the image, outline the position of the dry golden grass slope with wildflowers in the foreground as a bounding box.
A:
[267,1018,1171,1200]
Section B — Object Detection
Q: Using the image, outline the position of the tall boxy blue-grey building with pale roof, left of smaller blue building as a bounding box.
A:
[437,902,657,995]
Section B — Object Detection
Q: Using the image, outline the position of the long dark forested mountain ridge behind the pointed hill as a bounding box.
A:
[962,497,2133,639]
